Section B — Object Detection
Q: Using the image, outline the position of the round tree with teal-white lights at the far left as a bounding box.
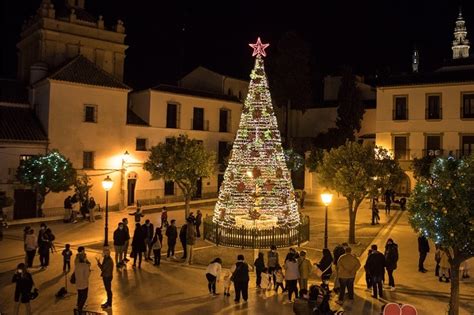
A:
[17,150,76,215]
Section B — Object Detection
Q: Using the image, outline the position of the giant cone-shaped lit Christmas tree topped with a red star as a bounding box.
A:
[213,38,300,229]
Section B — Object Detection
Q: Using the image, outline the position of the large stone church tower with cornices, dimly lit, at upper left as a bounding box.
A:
[17,0,128,83]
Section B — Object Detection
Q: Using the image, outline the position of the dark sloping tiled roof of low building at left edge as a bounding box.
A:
[0,106,48,142]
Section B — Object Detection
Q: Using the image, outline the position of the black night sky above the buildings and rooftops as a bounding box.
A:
[0,0,474,87]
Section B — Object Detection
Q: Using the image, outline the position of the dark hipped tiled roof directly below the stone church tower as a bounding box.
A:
[49,55,130,90]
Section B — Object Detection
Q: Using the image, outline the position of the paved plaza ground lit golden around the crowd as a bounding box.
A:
[0,200,474,315]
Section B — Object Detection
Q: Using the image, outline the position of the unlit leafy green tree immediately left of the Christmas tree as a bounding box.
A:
[143,135,215,217]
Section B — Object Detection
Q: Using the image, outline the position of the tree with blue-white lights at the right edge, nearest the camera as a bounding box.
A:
[408,155,474,315]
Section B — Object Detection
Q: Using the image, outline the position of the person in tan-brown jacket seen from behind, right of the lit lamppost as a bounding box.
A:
[336,247,360,304]
